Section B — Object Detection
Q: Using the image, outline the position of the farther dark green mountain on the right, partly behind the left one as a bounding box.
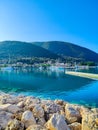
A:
[33,41,98,62]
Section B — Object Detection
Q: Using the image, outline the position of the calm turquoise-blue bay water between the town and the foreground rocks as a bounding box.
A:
[0,69,98,107]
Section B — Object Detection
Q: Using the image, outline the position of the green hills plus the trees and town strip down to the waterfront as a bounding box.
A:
[0,41,98,66]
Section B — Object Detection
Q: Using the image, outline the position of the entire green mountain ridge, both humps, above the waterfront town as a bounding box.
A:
[0,41,98,62]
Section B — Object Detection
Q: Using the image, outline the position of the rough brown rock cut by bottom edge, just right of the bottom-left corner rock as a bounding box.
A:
[5,119,24,130]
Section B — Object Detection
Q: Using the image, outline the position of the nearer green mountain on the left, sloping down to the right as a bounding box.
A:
[0,41,59,59]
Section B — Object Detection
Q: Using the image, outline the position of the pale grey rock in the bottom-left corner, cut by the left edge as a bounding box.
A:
[0,111,12,129]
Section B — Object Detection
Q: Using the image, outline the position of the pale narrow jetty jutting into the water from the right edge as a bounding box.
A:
[65,71,98,80]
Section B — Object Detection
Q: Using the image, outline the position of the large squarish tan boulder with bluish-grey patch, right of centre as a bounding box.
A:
[65,104,81,123]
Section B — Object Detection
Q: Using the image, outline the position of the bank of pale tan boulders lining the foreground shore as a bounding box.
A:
[0,94,98,130]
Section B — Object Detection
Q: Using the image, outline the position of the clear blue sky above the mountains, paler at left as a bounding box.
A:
[0,0,98,53]
